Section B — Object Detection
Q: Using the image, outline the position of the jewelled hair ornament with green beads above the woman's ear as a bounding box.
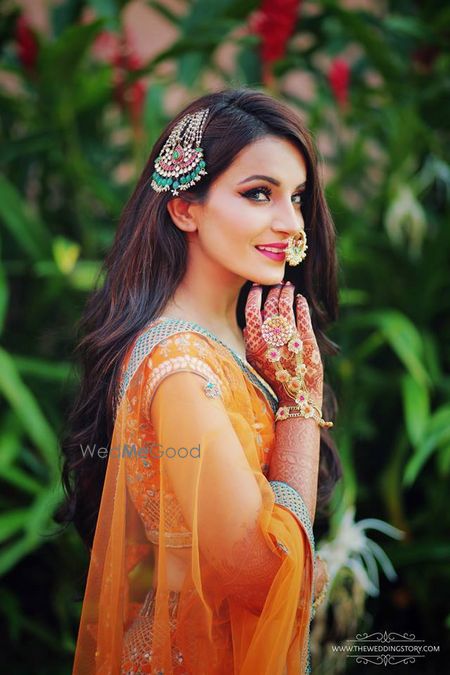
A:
[151,108,209,197]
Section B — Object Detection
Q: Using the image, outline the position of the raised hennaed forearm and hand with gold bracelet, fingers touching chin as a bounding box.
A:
[244,282,326,604]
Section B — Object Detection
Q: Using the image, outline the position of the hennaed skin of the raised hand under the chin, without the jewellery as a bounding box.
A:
[243,284,323,409]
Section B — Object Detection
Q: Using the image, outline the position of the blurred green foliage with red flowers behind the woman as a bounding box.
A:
[0,0,450,675]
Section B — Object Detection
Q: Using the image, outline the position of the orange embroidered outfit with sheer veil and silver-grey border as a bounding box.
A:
[73,317,314,675]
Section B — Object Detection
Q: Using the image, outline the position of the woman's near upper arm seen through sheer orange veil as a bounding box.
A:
[150,372,299,612]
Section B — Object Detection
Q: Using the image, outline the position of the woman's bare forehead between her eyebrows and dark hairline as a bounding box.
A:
[225,136,306,184]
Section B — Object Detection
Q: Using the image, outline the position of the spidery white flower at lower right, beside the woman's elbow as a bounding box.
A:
[317,506,405,595]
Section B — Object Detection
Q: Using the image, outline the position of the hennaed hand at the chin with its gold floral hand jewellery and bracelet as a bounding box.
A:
[243,282,333,427]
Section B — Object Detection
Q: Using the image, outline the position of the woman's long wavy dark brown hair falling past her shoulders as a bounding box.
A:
[55,87,342,548]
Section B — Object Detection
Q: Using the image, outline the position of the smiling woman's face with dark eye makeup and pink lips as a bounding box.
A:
[172,136,306,285]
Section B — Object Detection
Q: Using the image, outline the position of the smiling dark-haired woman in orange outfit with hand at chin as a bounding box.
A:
[60,88,341,675]
